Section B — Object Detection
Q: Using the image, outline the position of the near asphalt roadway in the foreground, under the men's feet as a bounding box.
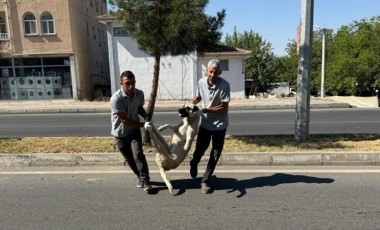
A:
[0,166,380,230]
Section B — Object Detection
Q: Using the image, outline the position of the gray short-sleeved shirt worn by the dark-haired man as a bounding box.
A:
[110,89,144,137]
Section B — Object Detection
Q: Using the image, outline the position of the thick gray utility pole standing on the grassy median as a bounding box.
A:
[294,0,314,142]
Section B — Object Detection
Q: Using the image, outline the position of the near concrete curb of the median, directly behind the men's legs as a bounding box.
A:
[0,152,380,167]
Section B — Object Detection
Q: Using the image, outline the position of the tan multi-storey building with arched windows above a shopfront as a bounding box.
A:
[0,0,110,100]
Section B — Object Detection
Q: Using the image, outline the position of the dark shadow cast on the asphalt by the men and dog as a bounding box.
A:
[148,173,334,198]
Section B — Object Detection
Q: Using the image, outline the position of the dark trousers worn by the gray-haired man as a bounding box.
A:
[190,127,227,184]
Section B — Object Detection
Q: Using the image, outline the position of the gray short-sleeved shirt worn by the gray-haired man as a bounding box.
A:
[196,77,230,131]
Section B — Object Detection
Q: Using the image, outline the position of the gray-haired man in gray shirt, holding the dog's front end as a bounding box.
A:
[190,59,230,194]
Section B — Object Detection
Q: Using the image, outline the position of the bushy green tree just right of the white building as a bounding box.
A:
[224,30,275,94]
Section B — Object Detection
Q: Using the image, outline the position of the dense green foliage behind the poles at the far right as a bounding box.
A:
[276,16,380,96]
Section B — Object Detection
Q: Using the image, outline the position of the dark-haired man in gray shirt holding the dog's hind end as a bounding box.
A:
[110,71,152,191]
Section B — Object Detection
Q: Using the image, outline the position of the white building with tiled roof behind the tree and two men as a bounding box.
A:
[98,15,252,100]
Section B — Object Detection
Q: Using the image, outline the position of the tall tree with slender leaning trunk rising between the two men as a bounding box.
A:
[109,0,225,143]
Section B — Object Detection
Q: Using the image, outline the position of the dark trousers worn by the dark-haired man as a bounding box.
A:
[115,128,150,181]
